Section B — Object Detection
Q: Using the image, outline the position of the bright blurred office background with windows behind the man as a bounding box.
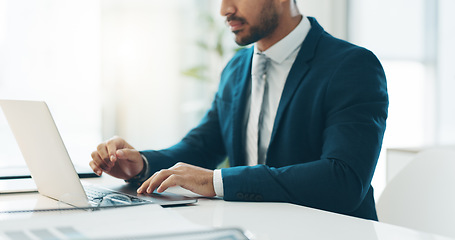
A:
[0,0,455,200]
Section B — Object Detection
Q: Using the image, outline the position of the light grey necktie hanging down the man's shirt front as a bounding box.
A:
[246,53,269,165]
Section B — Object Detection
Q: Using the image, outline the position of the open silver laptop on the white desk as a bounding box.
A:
[0,100,197,208]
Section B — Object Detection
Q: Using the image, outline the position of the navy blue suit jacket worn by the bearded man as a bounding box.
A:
[142,18,388,220]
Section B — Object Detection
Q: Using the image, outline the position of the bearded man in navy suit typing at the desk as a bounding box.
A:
[90,0,388,220]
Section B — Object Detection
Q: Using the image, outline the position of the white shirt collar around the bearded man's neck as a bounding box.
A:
[254,16,311,63]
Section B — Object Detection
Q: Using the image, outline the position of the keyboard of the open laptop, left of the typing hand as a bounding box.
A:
[84,185,150,207]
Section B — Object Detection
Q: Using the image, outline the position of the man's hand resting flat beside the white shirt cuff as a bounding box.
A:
[137,163,216,197]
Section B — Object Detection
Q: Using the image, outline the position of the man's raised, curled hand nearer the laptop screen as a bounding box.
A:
[90,137,144,180]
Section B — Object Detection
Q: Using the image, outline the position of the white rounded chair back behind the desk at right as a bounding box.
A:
[376,149,455,238]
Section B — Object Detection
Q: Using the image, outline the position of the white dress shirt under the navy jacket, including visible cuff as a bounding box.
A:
[213,17,311,197]
